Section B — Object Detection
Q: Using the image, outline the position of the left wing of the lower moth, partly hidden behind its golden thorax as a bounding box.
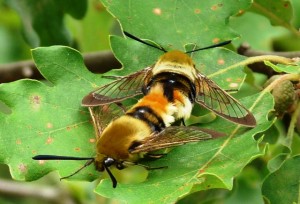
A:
[89,103,127,138]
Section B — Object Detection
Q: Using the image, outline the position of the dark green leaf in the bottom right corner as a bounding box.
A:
[262,155,300,204]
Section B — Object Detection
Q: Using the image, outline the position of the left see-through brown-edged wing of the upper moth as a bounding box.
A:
[82,67,152,107]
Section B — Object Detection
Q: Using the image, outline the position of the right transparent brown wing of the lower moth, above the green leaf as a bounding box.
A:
[130,126,225,153]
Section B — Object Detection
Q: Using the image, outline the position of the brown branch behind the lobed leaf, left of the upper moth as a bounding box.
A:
[0,51,121,83]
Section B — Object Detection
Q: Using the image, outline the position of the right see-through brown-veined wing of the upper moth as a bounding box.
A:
[195,73,256,127]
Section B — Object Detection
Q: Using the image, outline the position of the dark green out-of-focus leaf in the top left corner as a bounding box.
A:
[8,0,87,47]
